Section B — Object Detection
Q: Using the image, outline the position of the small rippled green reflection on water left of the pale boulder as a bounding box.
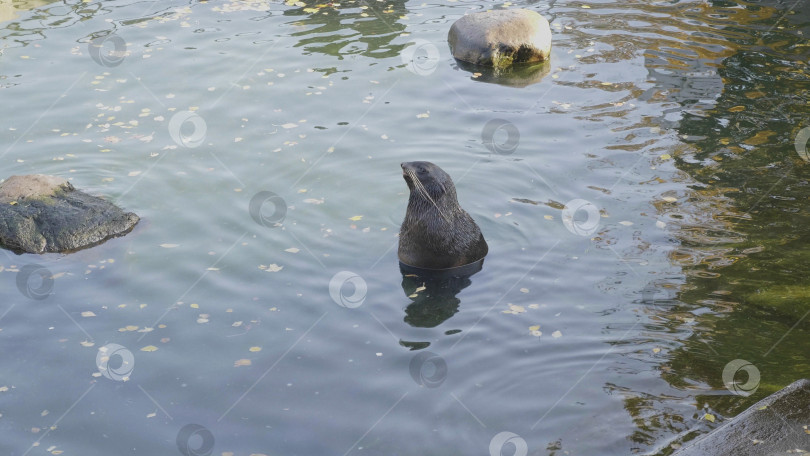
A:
[284,0,408,59]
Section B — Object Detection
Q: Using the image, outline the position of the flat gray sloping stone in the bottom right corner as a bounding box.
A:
[673,379,810,456]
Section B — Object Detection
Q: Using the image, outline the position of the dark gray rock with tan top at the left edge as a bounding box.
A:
[0,174,140,253]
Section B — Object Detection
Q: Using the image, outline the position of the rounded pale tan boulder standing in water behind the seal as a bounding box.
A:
[447,9,551,68]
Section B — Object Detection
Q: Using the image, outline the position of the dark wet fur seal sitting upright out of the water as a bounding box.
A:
[399,161,489,269]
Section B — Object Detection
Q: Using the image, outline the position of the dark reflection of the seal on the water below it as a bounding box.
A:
[399,258,484,328]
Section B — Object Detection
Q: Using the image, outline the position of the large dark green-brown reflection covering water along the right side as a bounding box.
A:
[607,1,810,448]
